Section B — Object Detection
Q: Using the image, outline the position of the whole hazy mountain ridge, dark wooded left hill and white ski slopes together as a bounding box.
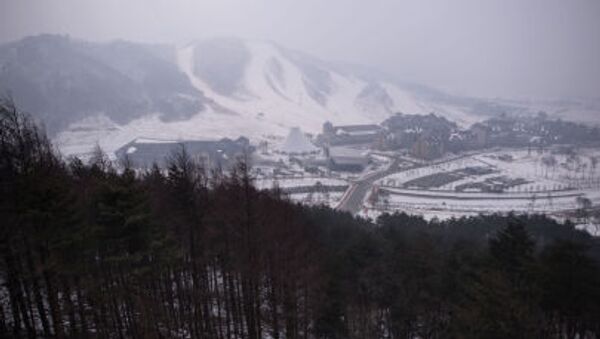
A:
[0,35,596,154]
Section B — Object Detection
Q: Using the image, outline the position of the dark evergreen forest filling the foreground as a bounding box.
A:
[0,101,600,339]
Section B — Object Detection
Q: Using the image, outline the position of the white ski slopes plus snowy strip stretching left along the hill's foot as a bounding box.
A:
[55,39,481,158]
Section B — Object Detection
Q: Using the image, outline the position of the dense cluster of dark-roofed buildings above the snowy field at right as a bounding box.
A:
[380,113,600,160]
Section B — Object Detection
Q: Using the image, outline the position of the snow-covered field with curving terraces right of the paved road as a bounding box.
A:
[370,149,600,218]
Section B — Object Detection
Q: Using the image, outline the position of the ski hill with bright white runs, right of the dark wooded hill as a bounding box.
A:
[178,39,488,133]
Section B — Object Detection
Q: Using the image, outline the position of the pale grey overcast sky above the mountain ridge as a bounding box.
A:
[0,0,600,98]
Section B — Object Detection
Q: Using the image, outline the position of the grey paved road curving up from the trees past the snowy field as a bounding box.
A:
[336,152,480,214]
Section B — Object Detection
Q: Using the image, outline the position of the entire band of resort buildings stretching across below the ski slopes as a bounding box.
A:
[116,113,600,172]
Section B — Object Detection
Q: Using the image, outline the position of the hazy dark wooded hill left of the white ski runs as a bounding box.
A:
[0,35,205,135]
